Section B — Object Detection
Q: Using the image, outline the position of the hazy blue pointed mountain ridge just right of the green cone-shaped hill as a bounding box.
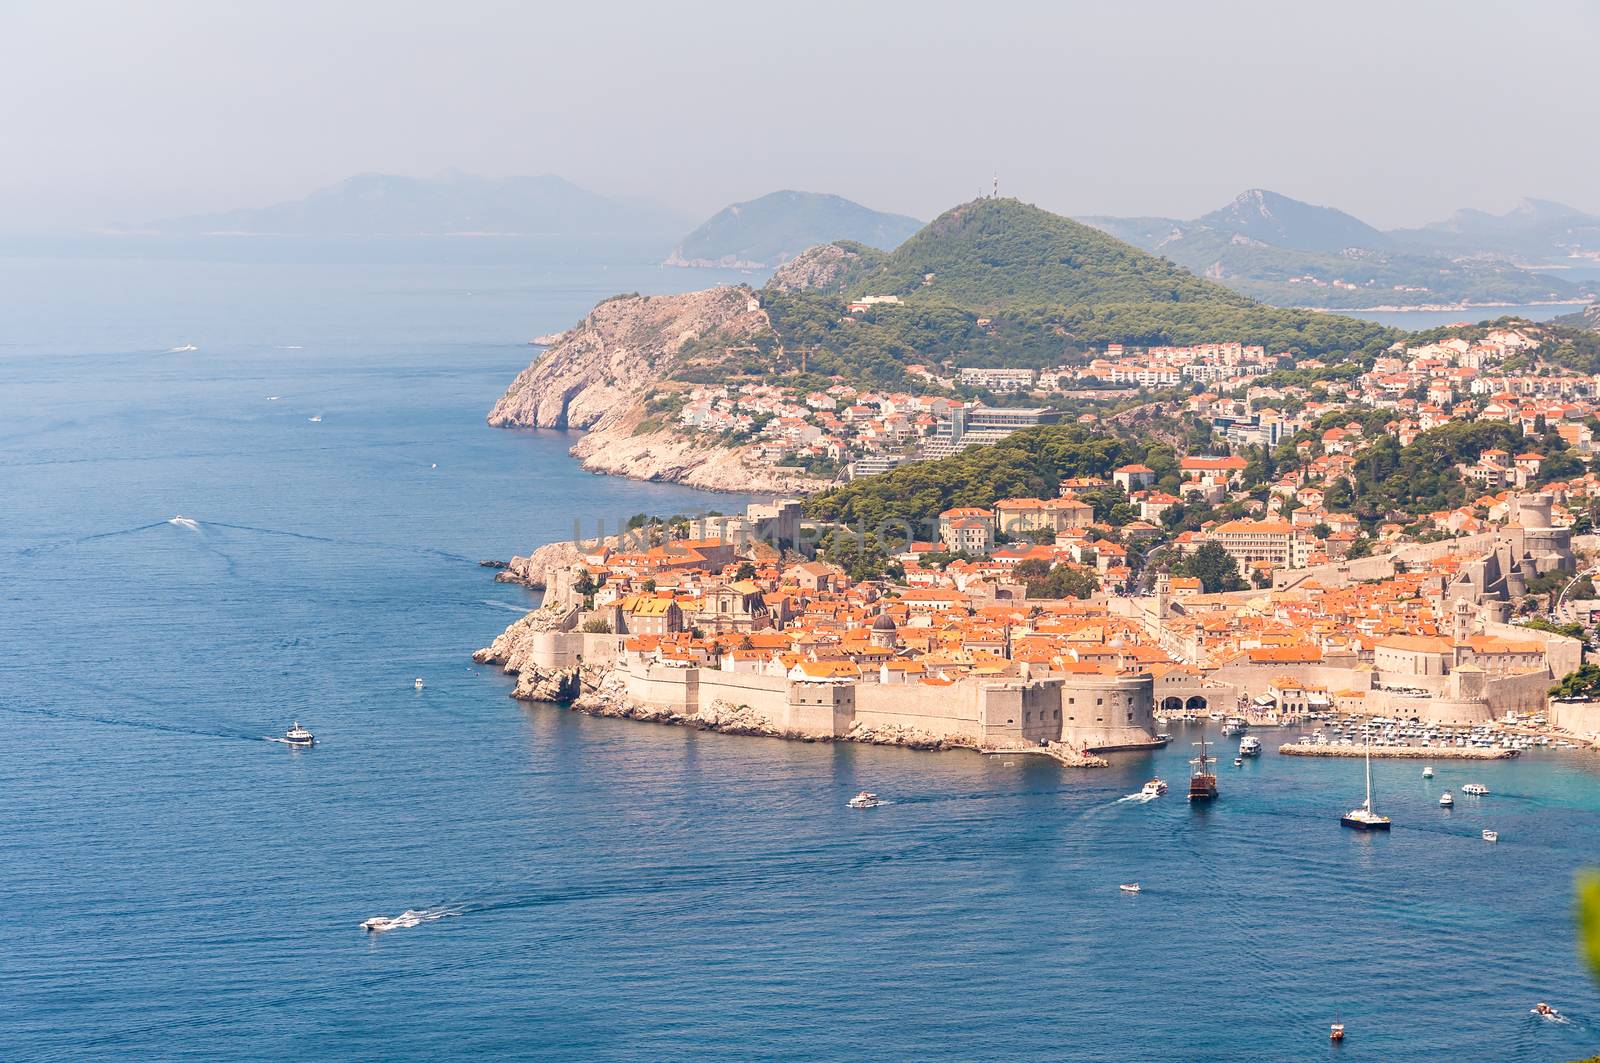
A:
[1083,189,1584,309]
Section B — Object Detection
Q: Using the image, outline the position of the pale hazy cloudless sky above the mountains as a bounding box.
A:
[0,0,1600,227]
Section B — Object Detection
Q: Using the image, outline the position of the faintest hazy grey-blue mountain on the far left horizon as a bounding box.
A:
[152,173,683,238]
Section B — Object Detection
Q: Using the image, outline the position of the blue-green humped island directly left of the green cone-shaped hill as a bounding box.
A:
[667,191,922,269]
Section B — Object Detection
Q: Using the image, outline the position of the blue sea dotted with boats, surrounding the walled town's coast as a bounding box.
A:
[0,236,1600,1061]
